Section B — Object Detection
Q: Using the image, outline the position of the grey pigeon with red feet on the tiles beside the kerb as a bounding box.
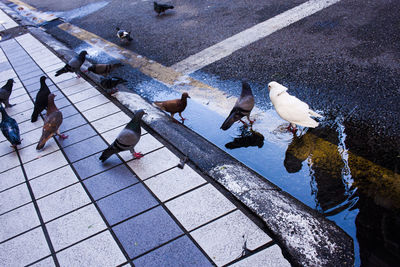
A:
[99,109,146,162]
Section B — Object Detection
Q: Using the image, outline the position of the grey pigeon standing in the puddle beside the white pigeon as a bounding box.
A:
[221,82,255,131]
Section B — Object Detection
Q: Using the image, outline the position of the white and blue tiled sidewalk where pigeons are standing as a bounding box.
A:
[0,30,290,266]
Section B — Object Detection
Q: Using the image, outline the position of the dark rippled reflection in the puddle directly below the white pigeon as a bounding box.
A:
[283,127,347,212]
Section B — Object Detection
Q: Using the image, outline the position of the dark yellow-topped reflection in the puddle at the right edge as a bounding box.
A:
[349,154,400,267]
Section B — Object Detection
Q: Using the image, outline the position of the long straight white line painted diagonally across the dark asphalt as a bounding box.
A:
[171,0,341,74]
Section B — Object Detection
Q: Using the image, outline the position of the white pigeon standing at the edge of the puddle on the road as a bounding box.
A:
[268,82,322,133]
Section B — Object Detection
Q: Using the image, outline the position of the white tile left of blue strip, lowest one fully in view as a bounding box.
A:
[46,204,107,251]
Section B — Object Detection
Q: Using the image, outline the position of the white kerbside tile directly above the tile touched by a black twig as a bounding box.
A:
[166,184,236,231]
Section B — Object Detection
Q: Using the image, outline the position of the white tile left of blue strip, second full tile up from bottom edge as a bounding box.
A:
[37,184,90,222]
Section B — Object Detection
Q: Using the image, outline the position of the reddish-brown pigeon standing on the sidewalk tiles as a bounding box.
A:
[36,94,68,150]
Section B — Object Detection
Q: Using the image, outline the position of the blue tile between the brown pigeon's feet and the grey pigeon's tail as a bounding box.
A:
[64,135,108,162]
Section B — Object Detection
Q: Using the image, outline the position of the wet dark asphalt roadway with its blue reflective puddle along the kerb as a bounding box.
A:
[3,0,400,266]
